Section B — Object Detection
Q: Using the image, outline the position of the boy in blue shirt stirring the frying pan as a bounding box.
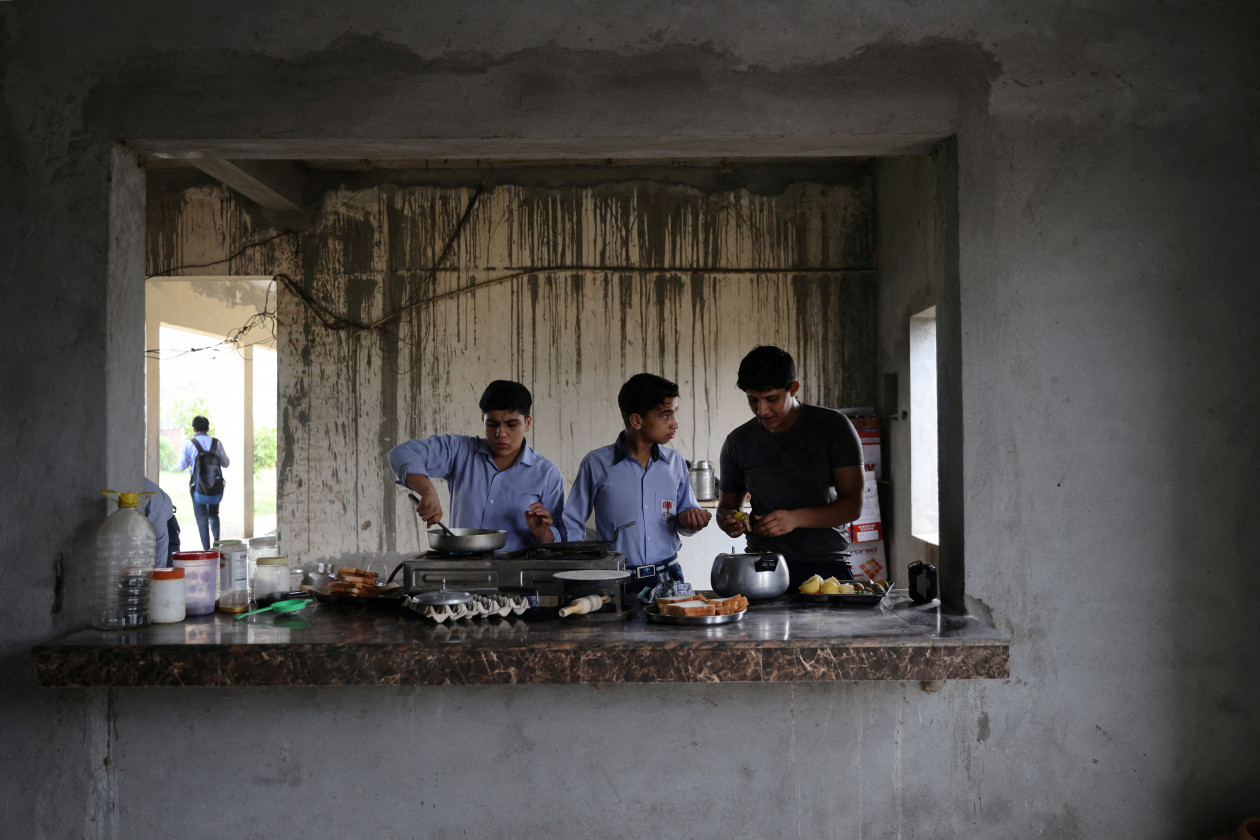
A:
[389,379,564,550]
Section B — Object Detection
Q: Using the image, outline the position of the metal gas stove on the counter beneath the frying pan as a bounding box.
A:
[402,548,626,607]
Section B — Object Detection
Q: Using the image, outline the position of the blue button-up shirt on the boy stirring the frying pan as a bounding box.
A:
[389,434,564,550]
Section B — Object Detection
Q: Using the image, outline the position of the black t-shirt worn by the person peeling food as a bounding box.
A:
[719,403,862,559]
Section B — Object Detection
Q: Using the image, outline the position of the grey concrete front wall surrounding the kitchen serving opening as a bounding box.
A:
[0,0,1260,837]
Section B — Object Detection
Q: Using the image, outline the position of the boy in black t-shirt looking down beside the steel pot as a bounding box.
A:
[717,346,866,587]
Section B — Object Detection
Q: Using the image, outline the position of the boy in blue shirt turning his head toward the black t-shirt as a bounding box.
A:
[563,373,709,593]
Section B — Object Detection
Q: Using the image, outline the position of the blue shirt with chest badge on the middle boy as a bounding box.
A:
[564,434,699,567]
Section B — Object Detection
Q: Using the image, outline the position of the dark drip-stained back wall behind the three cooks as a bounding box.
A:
[150,170,878,563]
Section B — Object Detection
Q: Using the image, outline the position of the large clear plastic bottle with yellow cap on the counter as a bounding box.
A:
[92,490,158,630]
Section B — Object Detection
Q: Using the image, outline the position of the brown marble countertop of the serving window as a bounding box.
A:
[34,589,1011,686]
